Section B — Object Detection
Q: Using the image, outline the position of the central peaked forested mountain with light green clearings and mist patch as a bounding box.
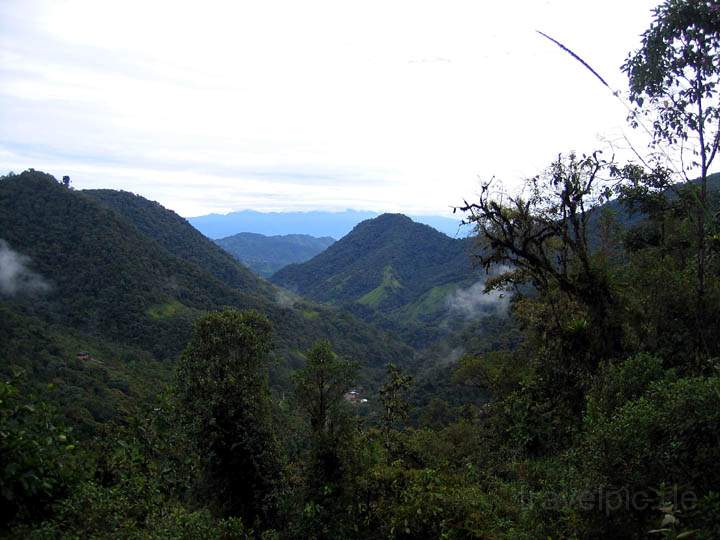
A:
[271,214,495,346]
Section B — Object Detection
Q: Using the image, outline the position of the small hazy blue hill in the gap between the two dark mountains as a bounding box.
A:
[215,233,335,277]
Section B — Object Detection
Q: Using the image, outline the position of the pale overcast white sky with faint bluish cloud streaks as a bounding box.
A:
[0,0,657,216]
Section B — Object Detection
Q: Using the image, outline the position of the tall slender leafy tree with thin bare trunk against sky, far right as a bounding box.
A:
[623,0,720,354]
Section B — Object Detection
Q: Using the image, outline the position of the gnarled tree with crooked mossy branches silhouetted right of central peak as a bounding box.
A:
[456,153,620,361]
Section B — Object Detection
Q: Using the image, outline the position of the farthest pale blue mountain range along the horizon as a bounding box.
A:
[188,210,469,239]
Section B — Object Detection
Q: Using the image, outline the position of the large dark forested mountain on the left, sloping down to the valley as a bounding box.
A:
[0,170,415,432]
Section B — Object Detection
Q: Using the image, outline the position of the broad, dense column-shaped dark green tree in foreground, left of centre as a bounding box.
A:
[175,310,281,523]
